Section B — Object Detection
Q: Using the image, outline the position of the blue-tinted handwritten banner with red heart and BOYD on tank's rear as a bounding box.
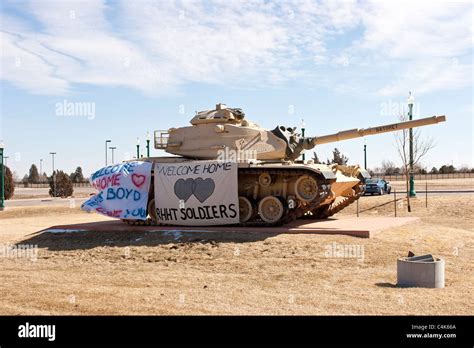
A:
[81,161,152,220]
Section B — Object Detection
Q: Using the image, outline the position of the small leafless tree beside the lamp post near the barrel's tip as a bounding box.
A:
[395,115,435,212]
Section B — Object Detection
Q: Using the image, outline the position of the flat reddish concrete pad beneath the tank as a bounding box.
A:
[41,217,419,238]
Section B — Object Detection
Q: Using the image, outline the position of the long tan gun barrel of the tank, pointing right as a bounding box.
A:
[305,115,446,149]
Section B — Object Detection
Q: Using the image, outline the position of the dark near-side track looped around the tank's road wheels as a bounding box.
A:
[122,167,331,227]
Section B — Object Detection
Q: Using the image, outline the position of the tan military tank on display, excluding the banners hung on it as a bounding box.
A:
[124,104,446,226]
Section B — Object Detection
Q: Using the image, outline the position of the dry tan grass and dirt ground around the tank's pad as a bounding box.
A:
[0,190,474,315]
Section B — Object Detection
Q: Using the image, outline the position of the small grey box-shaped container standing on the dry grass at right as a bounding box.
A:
[397,254,444,288]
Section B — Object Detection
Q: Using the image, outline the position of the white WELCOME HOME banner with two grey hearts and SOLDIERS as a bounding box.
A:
[155,161,239,226]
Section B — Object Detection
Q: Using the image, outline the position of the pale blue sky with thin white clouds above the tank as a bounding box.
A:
[0,0,474,178]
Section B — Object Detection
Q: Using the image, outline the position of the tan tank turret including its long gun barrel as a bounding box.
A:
[155,104,446,161]
